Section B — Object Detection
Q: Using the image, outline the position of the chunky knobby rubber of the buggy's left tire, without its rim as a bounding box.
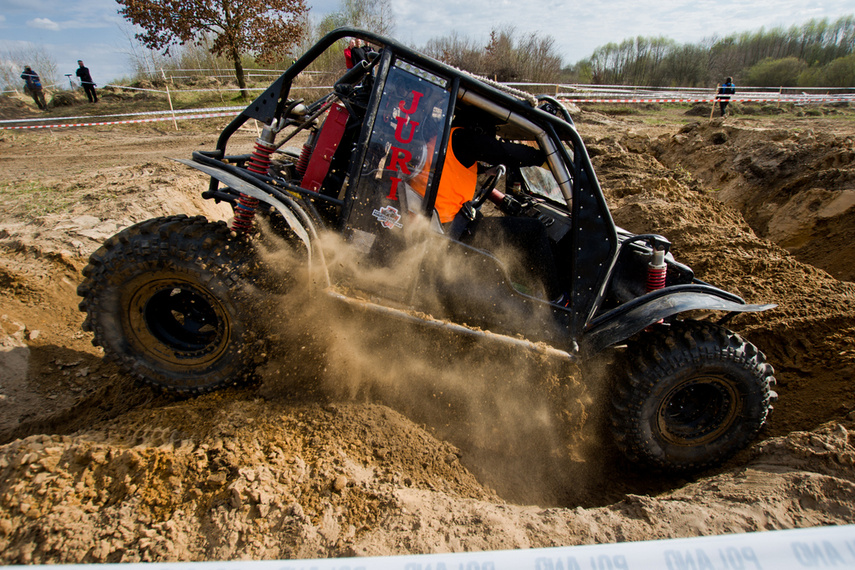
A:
[77,215,265,395]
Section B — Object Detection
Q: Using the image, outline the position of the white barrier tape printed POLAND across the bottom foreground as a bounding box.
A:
[7,525,855,570]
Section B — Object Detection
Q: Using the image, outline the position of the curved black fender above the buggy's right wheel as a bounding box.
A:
[579,283,777,354]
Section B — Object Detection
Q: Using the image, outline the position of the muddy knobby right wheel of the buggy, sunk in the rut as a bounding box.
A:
[611,321,776,472]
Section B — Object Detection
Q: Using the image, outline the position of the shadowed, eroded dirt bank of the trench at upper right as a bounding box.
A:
[649,105,855,281]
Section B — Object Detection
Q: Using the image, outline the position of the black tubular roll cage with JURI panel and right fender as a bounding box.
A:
[184,28,768,350]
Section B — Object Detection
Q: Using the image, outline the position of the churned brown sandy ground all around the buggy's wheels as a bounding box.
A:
[0,95,855,564]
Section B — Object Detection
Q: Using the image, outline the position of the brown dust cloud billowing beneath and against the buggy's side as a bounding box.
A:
[252,218,605,505]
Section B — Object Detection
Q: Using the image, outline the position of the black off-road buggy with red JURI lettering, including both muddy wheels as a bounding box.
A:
[78,29,775,471]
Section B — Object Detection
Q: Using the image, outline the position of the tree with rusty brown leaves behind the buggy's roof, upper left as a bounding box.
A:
[116,0,308,97]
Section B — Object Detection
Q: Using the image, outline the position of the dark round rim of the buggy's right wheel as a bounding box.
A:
[656,376,740,447]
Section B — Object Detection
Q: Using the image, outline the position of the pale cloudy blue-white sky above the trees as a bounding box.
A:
[0,0,855,85]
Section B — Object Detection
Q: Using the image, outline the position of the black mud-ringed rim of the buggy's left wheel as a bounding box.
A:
[128,280,230,368]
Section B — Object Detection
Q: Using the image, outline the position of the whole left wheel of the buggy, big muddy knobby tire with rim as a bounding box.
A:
[77,216,266,394]
